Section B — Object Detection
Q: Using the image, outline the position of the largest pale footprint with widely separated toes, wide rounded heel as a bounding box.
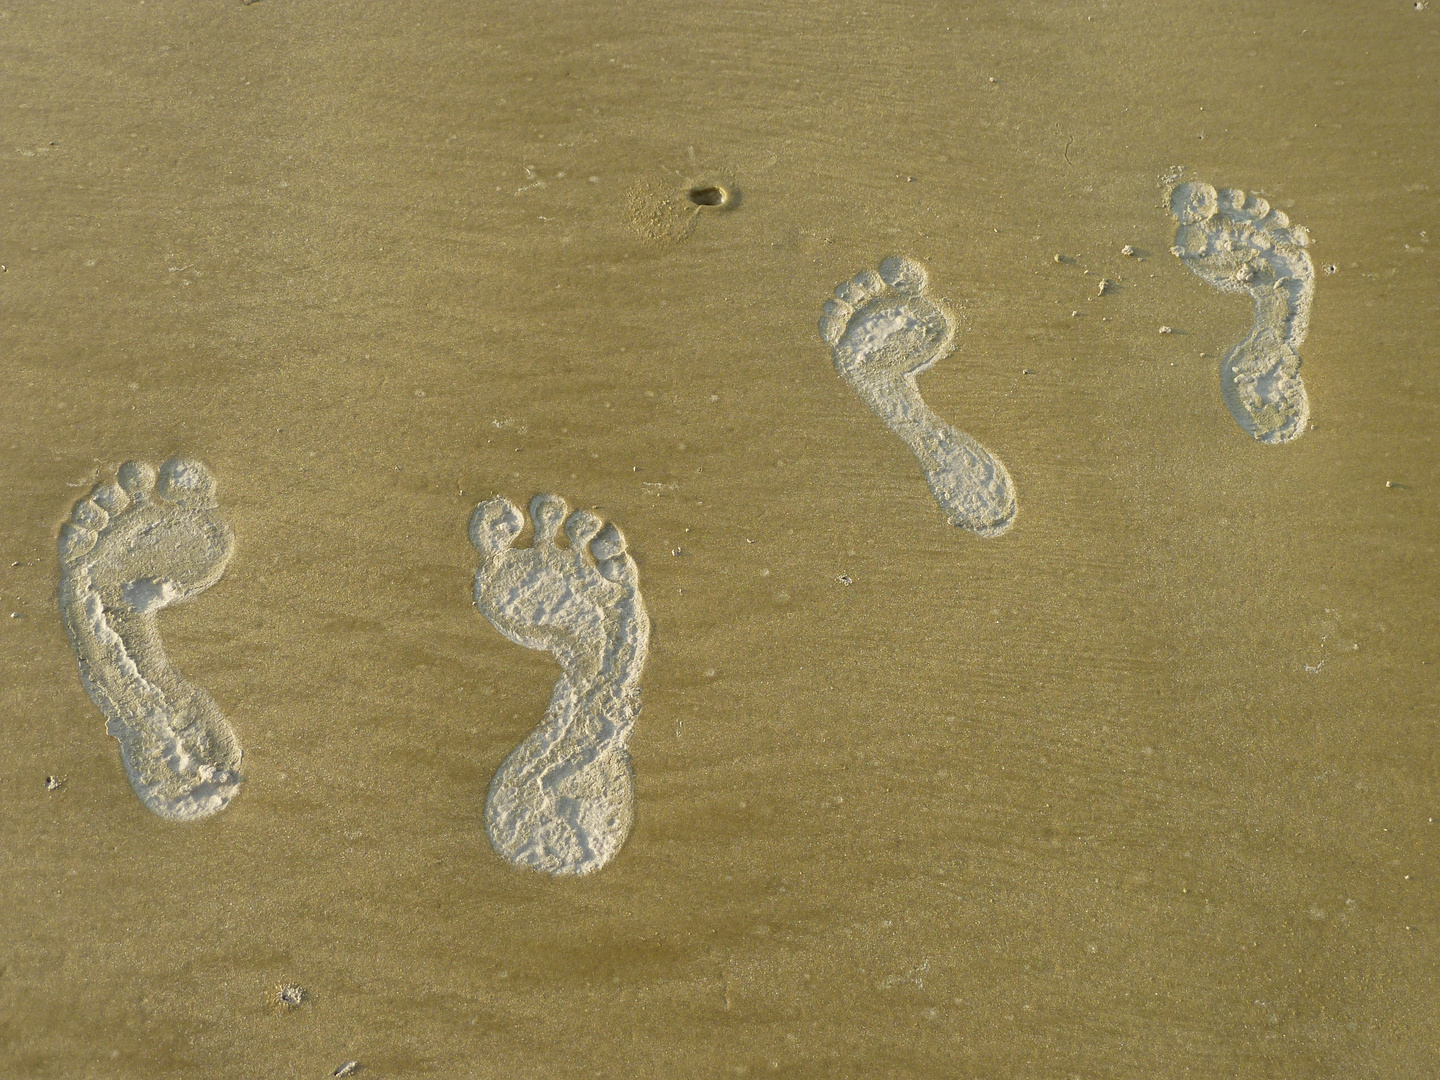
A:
[469,495,649,874]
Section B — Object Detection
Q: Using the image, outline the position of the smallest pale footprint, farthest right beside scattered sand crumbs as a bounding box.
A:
[1169,181,1315,444]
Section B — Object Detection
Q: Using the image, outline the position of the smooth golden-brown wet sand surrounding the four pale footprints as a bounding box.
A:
[0,0,1440,1080]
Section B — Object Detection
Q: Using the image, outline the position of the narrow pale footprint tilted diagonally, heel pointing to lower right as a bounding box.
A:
[819,258,1015,536]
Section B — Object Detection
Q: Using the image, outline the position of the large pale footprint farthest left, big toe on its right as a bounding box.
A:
[59,458,240,821]
